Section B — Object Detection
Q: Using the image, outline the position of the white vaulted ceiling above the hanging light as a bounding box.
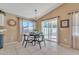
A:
[0,3,62,18]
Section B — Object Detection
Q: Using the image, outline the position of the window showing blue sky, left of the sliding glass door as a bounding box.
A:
[20,20,35,33]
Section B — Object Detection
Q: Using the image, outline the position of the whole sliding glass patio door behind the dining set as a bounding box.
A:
[42,18,58,42]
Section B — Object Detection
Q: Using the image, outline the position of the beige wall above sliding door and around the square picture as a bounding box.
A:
[37,3,79,47]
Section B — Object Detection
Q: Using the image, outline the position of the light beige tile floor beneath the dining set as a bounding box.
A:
[0,42,79,55]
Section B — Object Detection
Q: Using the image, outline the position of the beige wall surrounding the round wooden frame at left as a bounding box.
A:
[4,14,19,44]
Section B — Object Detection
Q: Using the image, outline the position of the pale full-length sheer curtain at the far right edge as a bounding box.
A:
[72,12,79,49]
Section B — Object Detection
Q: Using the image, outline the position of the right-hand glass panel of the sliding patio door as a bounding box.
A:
[49,19,57,41]
